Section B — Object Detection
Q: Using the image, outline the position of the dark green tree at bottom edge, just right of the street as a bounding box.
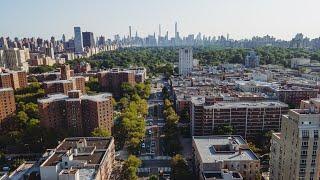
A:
[171,154,192,180]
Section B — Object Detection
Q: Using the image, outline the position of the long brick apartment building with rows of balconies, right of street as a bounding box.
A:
[191,97,288,138]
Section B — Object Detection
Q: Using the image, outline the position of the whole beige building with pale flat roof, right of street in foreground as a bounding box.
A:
[192,136,260,180]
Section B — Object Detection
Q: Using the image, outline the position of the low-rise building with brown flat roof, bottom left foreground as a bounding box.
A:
[40,137,115,180]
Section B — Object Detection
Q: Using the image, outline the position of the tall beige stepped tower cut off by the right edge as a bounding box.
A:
[270,99,320,180]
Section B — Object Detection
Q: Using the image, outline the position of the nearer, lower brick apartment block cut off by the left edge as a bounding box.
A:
[0,88,16,129]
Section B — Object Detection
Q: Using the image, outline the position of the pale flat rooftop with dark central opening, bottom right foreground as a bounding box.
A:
[193,136,259,163]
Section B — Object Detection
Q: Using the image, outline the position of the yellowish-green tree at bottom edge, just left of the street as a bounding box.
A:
[121,155,141,180]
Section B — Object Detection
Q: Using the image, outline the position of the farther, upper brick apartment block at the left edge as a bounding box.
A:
[0,71,28,90]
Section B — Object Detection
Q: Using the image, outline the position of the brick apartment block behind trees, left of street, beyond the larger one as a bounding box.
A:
[97,69,136,97]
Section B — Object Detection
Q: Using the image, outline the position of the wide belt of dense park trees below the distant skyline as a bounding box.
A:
[68,46,320,76]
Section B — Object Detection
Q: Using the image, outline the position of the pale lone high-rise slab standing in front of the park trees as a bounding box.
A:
[179,48,193,76]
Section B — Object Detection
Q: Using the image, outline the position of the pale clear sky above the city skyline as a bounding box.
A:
[0,0,320,40]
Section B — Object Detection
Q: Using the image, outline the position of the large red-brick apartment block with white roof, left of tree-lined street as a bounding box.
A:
[38,90,113,136]
